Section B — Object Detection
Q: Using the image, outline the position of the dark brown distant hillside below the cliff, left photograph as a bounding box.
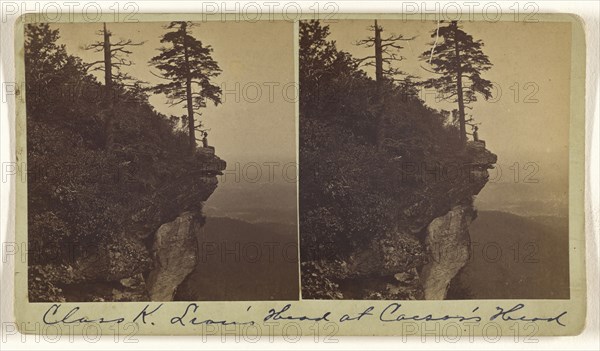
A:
[175,217,299,301]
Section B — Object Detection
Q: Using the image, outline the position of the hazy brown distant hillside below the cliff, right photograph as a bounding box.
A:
[448,211,569,299]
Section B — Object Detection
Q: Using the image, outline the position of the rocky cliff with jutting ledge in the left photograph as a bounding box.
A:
[29,149,226,301]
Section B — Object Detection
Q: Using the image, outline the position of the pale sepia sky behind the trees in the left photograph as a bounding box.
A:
[52,21,297,165]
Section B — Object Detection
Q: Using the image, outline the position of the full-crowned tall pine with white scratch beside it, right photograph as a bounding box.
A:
[421,21,492,144]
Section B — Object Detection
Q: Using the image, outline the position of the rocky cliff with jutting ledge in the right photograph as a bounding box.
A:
[302,142,497,299]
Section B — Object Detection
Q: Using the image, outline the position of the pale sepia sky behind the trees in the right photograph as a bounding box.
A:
[328,20,571,193]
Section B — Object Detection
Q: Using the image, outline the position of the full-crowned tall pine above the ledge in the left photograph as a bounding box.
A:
[150,21,221,150]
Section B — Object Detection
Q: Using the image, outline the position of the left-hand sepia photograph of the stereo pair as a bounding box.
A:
[24,21,299,302]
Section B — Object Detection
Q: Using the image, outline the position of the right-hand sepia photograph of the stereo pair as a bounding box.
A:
[299,19,571,300]
